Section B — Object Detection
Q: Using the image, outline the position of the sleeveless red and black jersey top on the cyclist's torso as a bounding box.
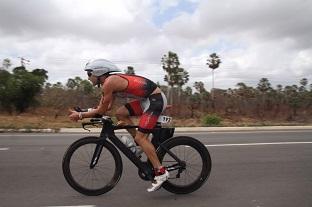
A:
[115,74,157,98]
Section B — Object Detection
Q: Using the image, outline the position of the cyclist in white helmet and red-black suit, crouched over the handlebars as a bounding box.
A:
[69,59,169,192]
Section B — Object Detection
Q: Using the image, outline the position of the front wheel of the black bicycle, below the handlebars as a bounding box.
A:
[62,137,122,196]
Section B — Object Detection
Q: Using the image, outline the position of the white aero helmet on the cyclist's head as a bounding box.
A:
[84,59,121,76]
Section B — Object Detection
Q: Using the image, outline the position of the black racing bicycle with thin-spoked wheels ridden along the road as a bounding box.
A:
[62,109,211,196]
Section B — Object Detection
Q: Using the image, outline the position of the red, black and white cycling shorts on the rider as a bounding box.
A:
[125,93,167,133]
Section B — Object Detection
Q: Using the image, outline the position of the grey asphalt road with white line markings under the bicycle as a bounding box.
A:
[0,130,312,207]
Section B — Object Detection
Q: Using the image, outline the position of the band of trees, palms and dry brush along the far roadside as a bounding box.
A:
[0,52,312,128]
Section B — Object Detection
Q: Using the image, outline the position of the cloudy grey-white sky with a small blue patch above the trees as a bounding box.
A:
[0,0,312,90]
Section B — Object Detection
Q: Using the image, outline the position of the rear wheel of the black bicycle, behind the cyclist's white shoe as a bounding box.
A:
[157,136,211,194]
